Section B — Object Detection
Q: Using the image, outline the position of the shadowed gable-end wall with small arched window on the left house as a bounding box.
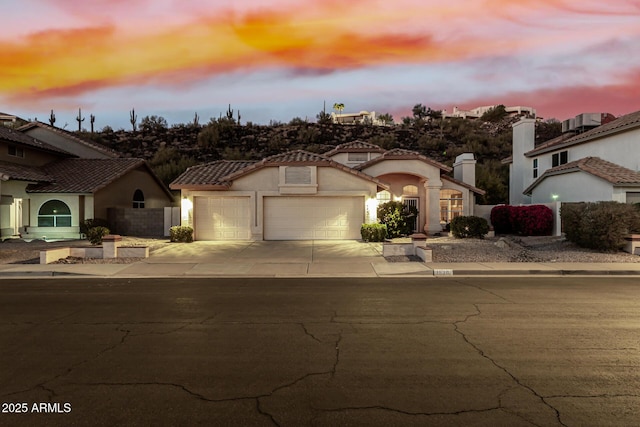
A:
[94,168,173,218]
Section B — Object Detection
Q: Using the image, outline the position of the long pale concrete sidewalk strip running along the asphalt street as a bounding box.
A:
[0,258,640,280]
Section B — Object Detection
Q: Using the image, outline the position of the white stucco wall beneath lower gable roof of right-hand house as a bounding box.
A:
[531,172,613,203]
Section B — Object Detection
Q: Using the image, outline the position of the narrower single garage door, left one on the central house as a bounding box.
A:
[194,197,251,240]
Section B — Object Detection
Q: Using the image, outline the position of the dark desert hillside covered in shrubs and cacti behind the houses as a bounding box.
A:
[79,104,561,204]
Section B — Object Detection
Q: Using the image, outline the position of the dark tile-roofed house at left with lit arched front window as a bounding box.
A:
[0,126,173,239]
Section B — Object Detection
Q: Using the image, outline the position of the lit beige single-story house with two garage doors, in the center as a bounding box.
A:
[170,141,484,240]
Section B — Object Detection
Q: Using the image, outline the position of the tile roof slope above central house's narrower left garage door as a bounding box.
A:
[169,160,256,190]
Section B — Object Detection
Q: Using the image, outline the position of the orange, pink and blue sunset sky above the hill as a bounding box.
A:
[0,0,640,129]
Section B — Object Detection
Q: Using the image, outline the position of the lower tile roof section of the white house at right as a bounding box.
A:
[524,157,640,194]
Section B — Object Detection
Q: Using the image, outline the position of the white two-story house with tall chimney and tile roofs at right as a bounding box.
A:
[504,111,640,205]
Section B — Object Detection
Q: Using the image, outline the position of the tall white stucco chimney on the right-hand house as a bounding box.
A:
[509,119,536,205]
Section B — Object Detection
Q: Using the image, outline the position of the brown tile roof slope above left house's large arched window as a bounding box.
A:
[27,159,150,193]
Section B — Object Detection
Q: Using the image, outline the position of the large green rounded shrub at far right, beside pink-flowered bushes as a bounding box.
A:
[561,202,640,251]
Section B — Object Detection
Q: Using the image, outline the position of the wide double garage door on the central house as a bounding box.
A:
[264,197,364,240]
